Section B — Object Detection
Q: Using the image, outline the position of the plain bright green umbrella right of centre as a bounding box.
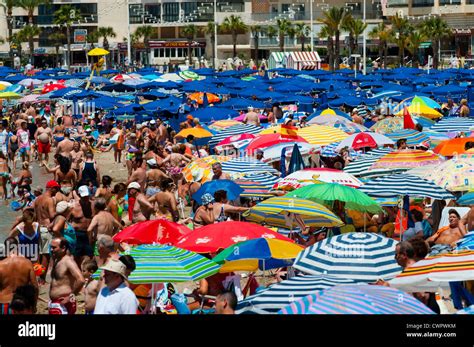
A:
[285,183,382,213]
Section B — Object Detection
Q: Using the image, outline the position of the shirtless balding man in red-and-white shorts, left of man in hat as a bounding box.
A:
[48,237,85,315]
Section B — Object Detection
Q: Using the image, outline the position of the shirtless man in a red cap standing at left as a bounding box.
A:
[33,181,61,284]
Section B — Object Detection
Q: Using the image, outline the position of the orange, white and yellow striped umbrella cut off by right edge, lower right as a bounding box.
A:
[389,250,474,292]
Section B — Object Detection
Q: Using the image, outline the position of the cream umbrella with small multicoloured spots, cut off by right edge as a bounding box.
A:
[408,156,474,192]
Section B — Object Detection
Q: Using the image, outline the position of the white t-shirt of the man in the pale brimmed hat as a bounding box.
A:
[94,283,138,314]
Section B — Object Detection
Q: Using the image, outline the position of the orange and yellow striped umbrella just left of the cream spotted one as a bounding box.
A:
[370,150,443,170]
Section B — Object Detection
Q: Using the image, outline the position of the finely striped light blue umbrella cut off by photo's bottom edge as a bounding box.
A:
[278,284,434,314]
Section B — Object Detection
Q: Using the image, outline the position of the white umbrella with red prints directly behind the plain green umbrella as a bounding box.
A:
[273,168,362,190]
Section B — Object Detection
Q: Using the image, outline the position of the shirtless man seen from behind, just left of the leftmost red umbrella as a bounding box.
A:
[87,198,122,253]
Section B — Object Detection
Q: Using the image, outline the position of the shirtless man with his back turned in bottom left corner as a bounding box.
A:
[0,238,38,315]
